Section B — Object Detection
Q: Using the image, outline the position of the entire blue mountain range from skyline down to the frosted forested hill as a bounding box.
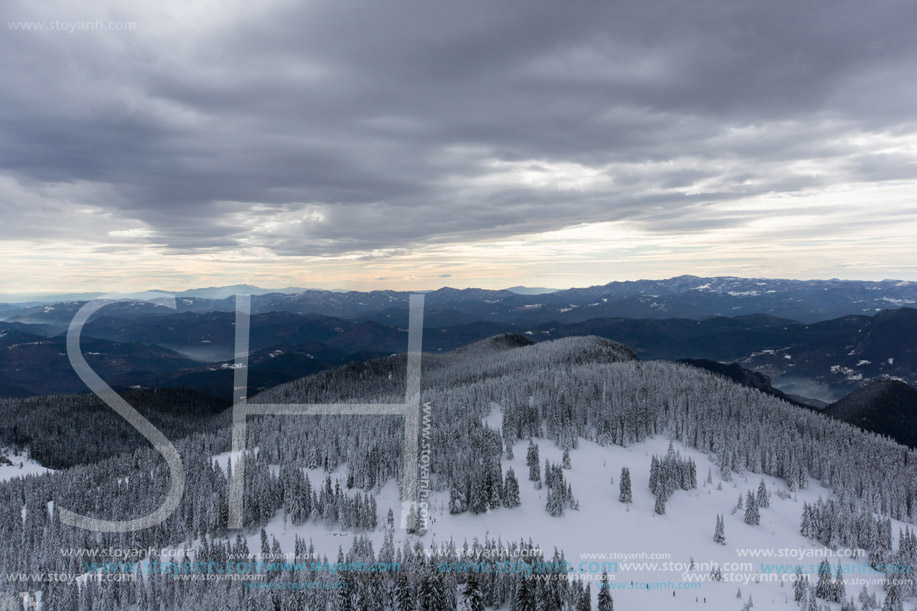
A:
[0,276,917,416]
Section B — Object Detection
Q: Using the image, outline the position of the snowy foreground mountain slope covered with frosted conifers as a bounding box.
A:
[0,337,917,611]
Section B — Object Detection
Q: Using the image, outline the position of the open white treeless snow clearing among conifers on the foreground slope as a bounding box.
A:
[195,405,901,611]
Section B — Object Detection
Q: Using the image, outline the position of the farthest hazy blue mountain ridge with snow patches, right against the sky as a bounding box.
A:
[0,276,917,326]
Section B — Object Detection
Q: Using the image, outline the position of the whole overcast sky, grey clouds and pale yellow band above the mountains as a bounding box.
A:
[0,0,917,293]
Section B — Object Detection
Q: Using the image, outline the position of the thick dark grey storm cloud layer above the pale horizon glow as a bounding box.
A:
[0,0,917,257]
